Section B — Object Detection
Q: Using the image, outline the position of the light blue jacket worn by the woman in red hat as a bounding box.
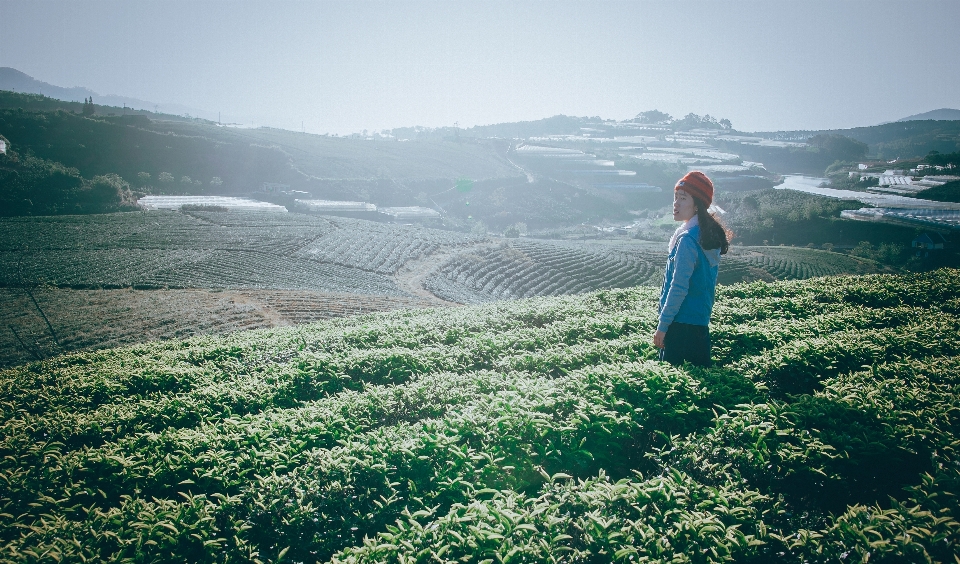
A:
[657,225,720,332]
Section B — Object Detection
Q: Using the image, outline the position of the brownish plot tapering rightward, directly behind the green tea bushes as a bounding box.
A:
[0,287,433,367]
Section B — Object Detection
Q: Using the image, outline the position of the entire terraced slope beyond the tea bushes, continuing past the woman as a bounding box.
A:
[0,211,878,367]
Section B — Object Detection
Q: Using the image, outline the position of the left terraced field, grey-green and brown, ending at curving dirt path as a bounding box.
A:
[0,211,464,366]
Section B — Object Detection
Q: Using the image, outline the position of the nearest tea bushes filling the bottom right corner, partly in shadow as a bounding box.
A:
[333,361,960,563]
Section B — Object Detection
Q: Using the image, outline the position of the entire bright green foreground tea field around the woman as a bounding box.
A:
[0,270,960,563]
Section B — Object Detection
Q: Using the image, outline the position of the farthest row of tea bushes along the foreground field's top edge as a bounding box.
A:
[2,275,956,434]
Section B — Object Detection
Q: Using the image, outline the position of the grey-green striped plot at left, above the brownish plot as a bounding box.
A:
[0,212,438,296]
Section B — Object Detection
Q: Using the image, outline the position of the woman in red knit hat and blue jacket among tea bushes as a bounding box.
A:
[653,171,732,366]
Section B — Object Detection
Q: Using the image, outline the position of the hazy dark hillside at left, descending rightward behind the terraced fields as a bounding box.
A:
[0,96,519,193]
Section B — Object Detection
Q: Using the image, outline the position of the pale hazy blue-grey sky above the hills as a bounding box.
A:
[0,0,960,133]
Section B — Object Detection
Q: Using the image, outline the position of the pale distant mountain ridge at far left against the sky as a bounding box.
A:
[0,67,223,121]
